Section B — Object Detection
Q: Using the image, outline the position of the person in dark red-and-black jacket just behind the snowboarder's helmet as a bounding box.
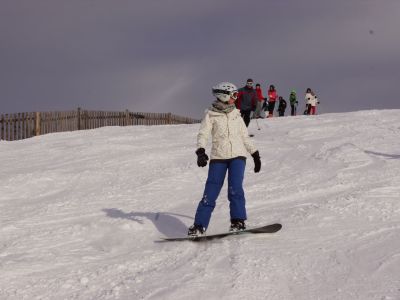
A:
[236,78,257,127]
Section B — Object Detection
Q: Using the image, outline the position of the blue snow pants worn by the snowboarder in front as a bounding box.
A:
[194,158,247,229]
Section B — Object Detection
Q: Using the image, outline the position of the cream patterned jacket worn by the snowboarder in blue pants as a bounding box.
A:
[197,108,257,159]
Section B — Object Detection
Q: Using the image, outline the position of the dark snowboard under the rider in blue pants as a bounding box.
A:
[161,223,282,242]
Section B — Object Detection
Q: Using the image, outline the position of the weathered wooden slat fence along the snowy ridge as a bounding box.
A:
[0,108,200,141]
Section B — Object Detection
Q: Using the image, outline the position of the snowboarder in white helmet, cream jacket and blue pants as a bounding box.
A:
[188,82,261,237]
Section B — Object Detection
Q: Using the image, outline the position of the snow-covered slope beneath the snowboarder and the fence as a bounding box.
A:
[0,110,400,300]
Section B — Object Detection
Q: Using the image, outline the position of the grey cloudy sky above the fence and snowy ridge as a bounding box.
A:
[0,0,400,117]
